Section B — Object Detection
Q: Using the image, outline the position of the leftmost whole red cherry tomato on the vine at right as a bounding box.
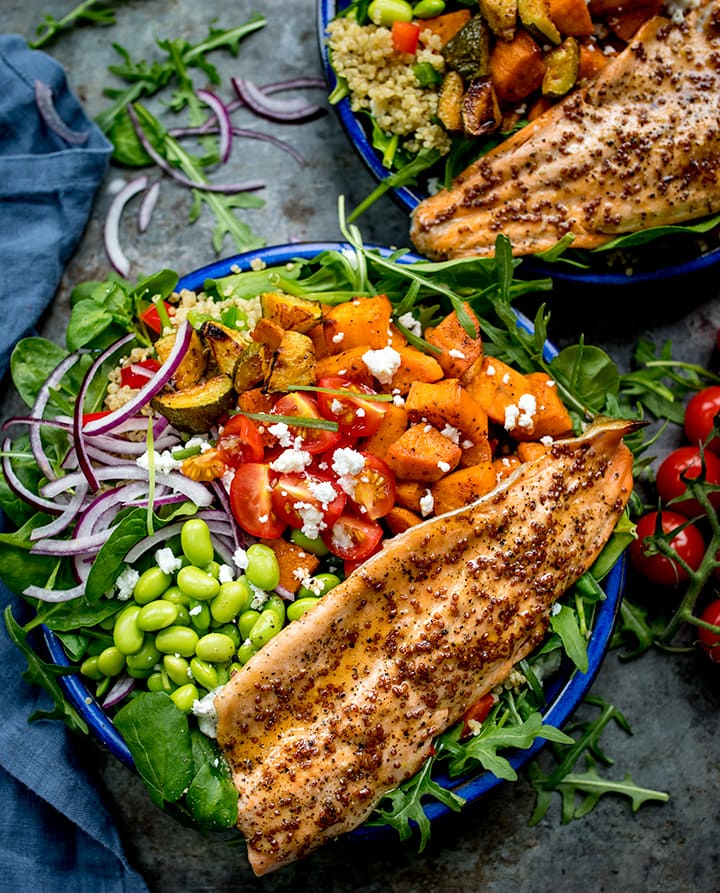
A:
[628,510,705,586]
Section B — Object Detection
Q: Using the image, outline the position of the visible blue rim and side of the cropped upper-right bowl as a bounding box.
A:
[317,0,720,286]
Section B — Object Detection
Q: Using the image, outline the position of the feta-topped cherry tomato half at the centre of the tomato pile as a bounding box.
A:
[272,471,347,539]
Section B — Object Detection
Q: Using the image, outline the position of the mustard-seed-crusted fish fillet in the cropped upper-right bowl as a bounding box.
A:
[411,0,720,259]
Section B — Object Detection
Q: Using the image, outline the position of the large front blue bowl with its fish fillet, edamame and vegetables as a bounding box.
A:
[1,216,636,874]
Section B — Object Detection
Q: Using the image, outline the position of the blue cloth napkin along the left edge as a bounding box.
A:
[0,35,148,893]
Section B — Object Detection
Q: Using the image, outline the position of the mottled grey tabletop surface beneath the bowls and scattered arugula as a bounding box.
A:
[0,0,720,893]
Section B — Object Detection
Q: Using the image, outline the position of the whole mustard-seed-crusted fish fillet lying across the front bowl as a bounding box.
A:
[215,421,634,875]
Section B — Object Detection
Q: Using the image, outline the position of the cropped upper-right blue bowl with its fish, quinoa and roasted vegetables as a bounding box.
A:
[318,0,720,285]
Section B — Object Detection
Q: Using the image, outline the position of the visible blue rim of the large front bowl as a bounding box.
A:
[43,242,625,840]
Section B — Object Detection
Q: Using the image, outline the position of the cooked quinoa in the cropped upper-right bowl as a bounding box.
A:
[327,18,450,154]
